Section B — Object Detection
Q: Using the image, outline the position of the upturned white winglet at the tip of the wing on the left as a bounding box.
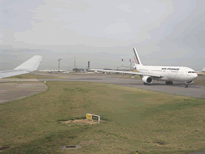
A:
[14,55,43,72]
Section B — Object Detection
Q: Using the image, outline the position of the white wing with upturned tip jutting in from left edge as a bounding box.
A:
[0,55,43,79]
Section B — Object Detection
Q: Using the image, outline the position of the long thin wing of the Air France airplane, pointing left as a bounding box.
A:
[90,69,162,78]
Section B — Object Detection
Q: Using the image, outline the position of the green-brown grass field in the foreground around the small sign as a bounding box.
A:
[0,82,205,154]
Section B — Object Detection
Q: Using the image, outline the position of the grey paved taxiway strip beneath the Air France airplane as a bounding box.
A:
[1,75,205,99]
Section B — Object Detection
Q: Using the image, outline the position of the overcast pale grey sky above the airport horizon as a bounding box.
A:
[0,0,205,70]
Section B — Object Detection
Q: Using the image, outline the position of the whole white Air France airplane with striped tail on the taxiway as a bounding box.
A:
[91,48,198,88]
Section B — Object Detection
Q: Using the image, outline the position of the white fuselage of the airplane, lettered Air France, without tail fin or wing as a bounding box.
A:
[136,65,198,81]
